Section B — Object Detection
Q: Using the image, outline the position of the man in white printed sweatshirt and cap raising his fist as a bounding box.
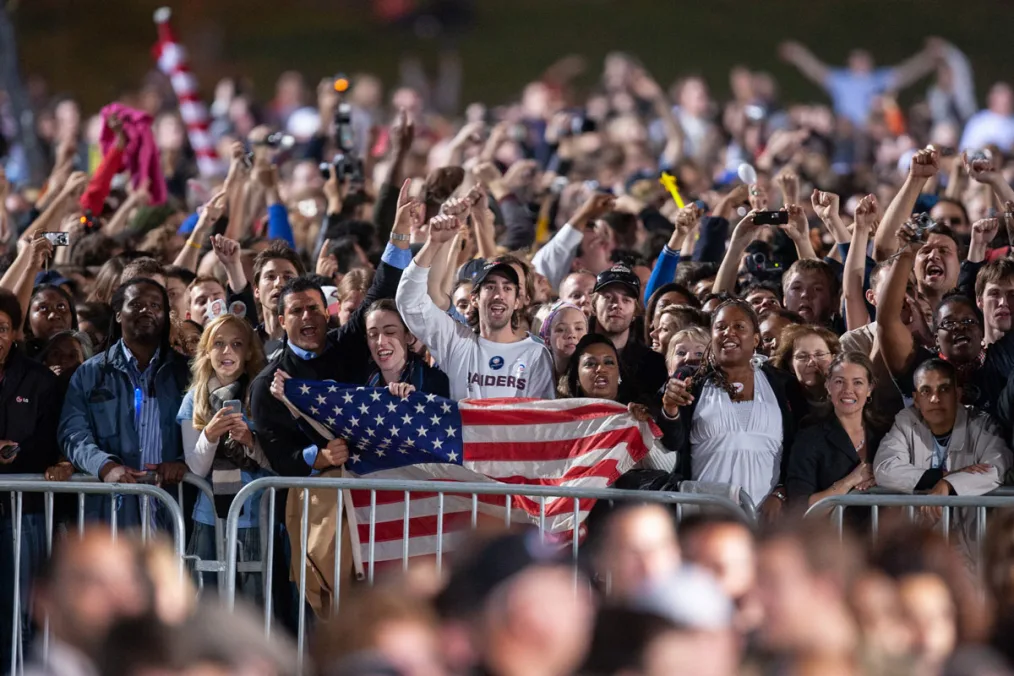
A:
[395,216,554,399]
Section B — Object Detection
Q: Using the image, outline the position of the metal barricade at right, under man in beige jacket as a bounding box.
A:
[804,487,1014,564]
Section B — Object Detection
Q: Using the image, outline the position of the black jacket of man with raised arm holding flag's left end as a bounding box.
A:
[250,262,402,476]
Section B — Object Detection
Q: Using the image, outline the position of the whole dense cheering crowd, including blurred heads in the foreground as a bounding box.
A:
[0,23,1014,676]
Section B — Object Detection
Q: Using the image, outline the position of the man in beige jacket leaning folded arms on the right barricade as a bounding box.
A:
[874,359,1012,506]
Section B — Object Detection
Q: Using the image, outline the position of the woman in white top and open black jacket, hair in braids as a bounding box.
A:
[662,300,808,517]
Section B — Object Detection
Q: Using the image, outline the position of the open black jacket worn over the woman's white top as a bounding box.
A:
[666,363,809,484]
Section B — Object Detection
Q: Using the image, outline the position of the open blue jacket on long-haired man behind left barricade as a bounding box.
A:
[57,341,190,476]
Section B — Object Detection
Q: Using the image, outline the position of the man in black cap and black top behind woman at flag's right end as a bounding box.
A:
[592,265,669,403]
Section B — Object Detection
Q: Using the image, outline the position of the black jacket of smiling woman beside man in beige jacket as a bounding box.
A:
[785,415,883,507]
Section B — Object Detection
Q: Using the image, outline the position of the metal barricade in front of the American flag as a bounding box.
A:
[224,477,756,669]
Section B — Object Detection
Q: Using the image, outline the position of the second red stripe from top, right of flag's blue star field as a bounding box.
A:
[464,427,647,462]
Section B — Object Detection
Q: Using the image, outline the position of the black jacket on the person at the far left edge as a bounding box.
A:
[0,350,62,512]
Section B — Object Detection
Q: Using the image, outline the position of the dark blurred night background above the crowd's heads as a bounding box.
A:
[8,0,1014,111]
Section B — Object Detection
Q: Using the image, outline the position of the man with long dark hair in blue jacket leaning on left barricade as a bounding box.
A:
[57,277,190,514]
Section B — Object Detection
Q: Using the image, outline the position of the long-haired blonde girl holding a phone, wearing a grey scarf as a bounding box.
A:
[176,314,271,599]
